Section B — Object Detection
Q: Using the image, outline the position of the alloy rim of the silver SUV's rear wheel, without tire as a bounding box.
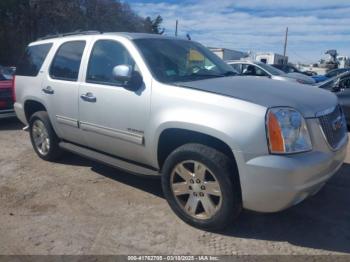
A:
[32,120,50,155]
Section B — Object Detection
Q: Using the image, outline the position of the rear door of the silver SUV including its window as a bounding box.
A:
[42,40,86,144]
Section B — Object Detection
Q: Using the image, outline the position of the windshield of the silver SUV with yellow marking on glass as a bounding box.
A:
[134,38,237,83]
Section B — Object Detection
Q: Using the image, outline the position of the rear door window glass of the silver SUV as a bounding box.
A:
[50,41,85,81]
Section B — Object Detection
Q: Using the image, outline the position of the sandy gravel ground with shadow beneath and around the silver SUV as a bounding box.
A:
[0,120,350,255]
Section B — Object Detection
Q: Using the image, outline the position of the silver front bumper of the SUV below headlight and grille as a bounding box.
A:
[240,138,347,212]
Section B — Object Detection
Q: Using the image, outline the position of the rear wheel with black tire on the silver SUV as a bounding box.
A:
[29,111,62,161]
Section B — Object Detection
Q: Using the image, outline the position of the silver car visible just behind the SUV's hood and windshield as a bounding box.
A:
[226,60,315,85]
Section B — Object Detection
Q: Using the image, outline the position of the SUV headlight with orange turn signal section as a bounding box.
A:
[266,107,312,154]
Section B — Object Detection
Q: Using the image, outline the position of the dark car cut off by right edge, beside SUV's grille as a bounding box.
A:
[317,71,350,127]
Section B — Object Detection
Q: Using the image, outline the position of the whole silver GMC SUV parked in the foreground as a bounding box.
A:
[15,32,348,230]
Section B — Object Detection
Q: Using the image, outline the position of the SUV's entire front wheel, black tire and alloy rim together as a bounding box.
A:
[162,144,242,230]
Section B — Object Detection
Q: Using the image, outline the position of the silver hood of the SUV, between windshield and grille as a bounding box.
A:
[177,76,338,118]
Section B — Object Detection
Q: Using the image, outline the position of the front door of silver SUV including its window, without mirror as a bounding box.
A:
[79,40,151,162]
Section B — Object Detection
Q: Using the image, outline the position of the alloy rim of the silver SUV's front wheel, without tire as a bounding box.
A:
[170,160,222,219]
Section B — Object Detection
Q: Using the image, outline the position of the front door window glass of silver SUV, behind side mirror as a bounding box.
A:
[86,40,137,85]
